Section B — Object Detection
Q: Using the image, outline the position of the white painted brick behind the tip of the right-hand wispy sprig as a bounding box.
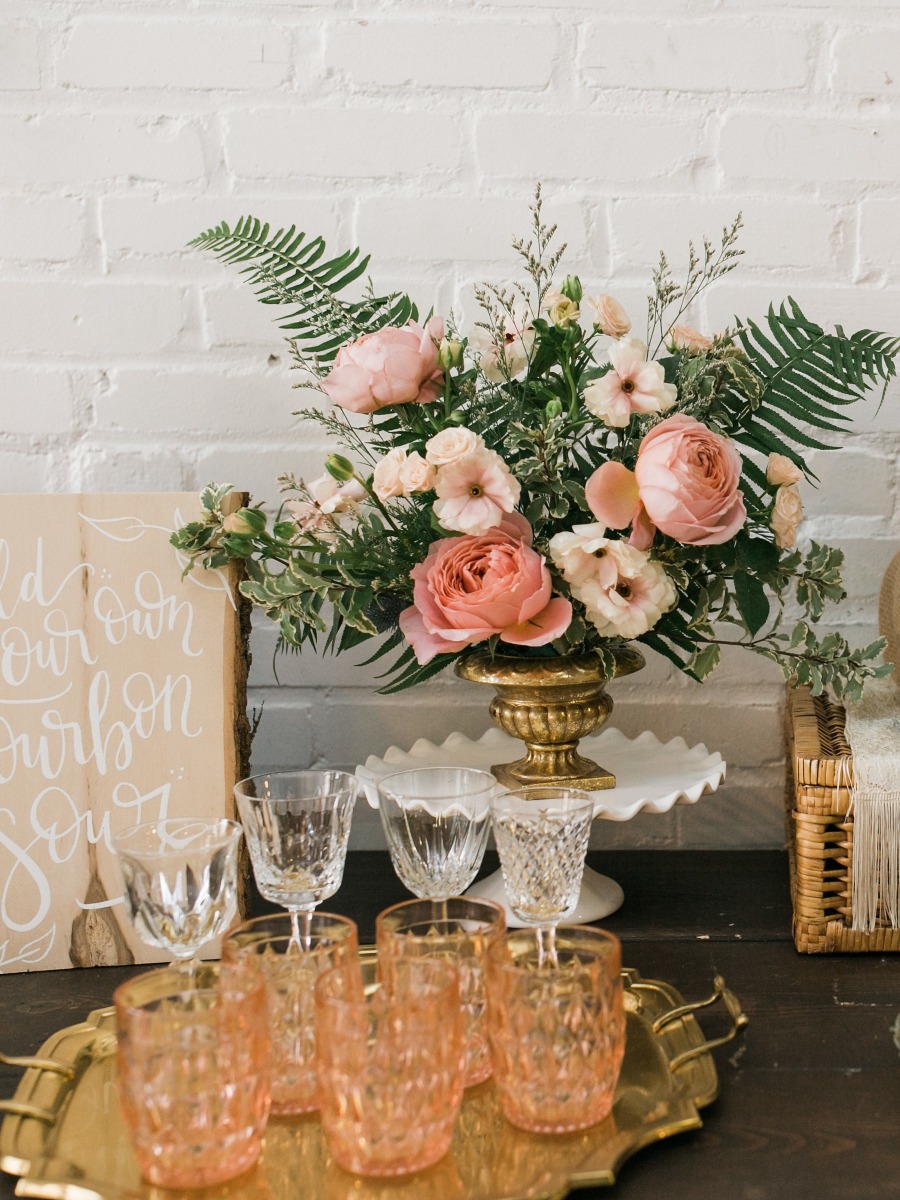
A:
[610,194,841,277]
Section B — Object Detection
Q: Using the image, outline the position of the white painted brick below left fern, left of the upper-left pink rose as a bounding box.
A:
[95,364,300,437]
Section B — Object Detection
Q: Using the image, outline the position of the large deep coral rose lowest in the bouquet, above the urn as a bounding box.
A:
[400,514,572,665]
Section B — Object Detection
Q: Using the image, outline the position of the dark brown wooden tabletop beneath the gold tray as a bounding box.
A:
[0,851,900,1200]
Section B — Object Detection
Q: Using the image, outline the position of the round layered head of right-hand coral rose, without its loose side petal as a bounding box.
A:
[635,413,746,546]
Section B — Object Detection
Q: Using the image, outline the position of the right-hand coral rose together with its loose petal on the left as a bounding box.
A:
[584,413,746,550]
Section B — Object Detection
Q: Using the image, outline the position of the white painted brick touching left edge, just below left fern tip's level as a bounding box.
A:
[0,280,184,358]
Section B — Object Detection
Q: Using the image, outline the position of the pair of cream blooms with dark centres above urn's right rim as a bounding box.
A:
[550,524,678,637]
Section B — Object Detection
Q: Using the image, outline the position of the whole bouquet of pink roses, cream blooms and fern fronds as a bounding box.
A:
[172,188,900,697]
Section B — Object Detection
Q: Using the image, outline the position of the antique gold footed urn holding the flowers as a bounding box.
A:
[456,646,644,792]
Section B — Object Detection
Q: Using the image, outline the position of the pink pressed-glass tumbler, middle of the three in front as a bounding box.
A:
[316,958,466,1175]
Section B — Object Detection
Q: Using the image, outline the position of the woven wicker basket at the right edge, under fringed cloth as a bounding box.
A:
[786,688,900,954]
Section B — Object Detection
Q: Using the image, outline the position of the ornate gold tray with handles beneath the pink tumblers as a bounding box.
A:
[0,971,746,1200]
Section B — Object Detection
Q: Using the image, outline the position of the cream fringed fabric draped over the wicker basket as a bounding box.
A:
[846,677,900,932]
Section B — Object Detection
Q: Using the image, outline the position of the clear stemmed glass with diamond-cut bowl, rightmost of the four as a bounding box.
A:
[491,784,594,961]
